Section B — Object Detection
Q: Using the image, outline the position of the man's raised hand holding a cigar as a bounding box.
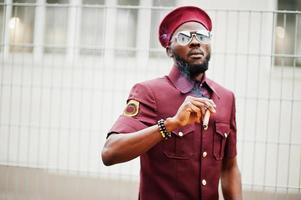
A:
[171,96,216,127]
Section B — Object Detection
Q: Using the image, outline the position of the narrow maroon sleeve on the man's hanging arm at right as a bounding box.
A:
[225,94,237,158]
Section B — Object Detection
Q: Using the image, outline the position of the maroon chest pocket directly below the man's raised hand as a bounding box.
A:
[162,125,195,160]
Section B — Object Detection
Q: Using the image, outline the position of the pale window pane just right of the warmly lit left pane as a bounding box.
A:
[45,6,68,53]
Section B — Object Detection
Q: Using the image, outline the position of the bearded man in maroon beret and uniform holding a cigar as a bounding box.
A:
[102,6,241,200]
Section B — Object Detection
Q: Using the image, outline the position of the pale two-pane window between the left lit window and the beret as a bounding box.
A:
[80,0,139,56]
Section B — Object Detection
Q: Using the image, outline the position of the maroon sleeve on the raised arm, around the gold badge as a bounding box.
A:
[108,83,157,135]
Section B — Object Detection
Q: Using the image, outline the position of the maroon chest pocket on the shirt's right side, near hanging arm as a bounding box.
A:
[213,122,230,160]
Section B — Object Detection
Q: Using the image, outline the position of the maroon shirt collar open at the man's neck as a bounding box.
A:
[168,66,219,96]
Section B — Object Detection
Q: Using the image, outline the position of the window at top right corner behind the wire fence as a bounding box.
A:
[274,0,301,67]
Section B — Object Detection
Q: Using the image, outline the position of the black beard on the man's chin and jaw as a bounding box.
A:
[174,54,210,79]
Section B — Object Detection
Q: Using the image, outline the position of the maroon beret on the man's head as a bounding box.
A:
[159,6,212,48]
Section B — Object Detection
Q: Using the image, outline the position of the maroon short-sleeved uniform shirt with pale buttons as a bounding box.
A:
[110,67,236,200]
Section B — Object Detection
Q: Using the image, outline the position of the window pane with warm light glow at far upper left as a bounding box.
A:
[9,1,35,52]
